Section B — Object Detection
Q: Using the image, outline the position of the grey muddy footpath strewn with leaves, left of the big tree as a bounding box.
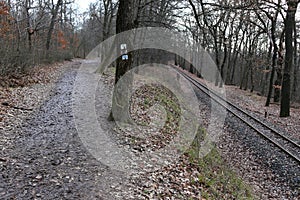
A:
[0,61,130,199]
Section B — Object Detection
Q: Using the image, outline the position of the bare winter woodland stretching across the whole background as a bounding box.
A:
[0,0,300,116]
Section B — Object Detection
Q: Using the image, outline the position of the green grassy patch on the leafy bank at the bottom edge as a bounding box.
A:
[187,130,255,199]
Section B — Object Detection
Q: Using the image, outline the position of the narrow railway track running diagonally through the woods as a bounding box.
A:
[177,69,300,164]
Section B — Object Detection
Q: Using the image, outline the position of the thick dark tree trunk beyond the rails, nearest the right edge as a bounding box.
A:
[280,0,298,117]
